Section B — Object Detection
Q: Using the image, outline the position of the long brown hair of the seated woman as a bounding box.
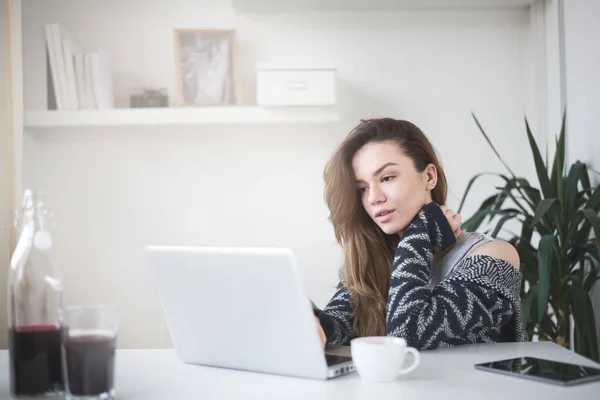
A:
[324,118,447,336]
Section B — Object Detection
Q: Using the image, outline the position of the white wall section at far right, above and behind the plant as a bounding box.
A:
[563,0,600,354]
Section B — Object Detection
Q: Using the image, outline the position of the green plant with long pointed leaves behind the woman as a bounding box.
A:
[459,115,600,361]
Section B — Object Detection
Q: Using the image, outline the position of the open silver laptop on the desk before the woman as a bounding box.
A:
[146,246,354,379]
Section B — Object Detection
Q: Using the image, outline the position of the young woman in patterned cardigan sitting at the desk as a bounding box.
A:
[315,118,525,350]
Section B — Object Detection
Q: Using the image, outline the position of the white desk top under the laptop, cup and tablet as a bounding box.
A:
[0,342,600,400]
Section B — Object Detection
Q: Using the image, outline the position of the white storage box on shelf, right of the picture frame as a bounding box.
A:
[256,65,337,106]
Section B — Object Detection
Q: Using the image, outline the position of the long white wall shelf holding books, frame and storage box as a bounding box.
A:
[24,106,339,129]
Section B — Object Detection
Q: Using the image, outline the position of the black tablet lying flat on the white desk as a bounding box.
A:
[475,357,600,386]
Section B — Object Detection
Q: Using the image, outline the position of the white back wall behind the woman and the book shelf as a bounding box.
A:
[23,0,533,347]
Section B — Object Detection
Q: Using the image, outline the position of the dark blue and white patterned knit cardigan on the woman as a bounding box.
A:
[315,203,525,350]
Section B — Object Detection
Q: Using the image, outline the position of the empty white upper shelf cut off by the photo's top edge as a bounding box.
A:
[232,0,536,13]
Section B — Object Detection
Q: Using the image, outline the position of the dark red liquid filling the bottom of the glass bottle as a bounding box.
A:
[8,325,64,396]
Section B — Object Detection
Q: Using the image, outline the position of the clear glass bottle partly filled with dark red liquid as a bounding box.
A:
[8,190,64,399]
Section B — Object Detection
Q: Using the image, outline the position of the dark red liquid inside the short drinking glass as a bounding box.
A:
[64,333,117,396]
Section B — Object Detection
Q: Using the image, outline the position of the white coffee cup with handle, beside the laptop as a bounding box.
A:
[350,336,421,382]
